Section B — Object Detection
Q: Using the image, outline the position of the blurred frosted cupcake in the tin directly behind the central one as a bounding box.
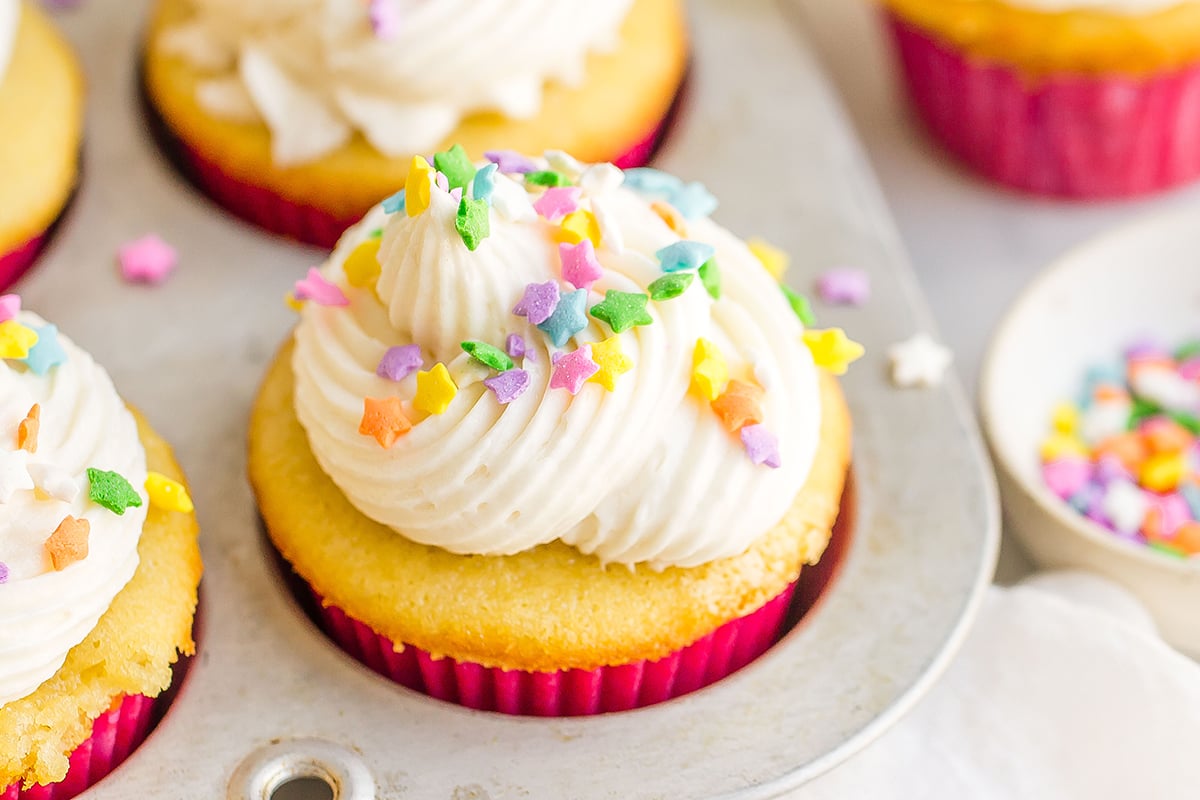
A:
[145,0,688,247]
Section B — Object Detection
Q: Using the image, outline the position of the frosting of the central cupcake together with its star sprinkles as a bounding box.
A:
[285,146,860,569]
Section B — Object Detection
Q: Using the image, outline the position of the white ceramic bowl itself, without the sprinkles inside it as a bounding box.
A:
[979,209,1200,655]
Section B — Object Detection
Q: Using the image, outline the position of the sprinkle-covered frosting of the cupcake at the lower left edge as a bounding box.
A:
[0,302,146,704]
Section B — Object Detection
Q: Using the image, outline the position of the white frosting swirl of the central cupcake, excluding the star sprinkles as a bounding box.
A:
[293,158,821,569]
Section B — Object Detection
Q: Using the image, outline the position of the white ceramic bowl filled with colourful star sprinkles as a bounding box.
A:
[979,209,1200,654]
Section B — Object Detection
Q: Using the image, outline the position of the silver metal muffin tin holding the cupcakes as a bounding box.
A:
[19,0,998,800]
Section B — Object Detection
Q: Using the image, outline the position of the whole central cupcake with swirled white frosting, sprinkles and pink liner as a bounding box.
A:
[250,146,862,716]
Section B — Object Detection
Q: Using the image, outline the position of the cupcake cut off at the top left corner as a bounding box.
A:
[0,0,84,288]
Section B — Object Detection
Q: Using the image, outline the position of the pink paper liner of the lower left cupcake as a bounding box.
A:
[0,694,158,800]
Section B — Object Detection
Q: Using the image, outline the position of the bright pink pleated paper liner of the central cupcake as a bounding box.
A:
[312,583,796,717]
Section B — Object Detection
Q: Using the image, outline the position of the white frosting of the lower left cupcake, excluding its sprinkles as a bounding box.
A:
[0,312,148,704]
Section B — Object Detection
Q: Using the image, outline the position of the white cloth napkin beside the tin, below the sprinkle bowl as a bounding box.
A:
[794,572,1200,800]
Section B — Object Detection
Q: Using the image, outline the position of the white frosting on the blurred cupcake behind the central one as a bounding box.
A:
[160,0,632,166]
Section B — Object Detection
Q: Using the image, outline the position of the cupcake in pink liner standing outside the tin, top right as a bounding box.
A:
[883,0,1200,199]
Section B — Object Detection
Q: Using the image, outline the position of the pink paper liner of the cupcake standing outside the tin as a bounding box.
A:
[888,13,1200,199]
